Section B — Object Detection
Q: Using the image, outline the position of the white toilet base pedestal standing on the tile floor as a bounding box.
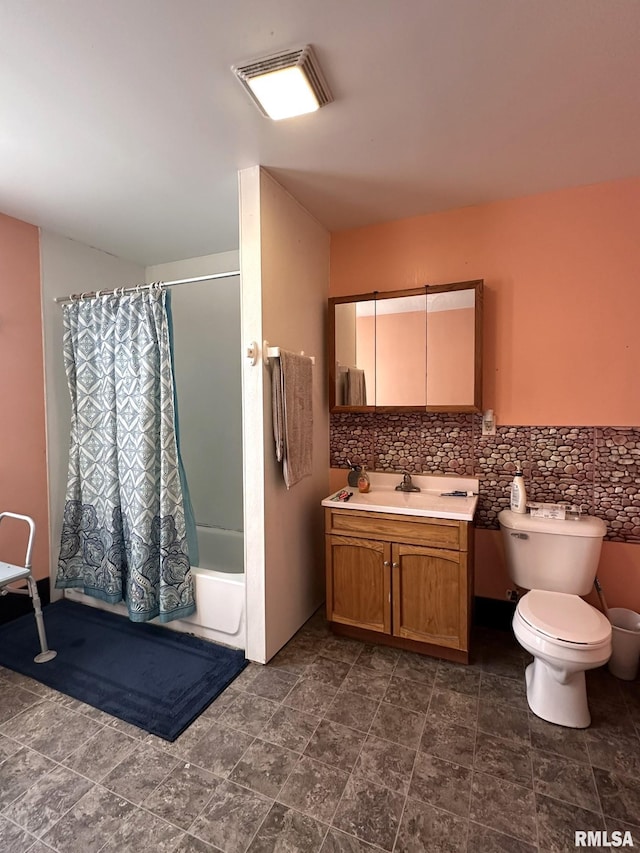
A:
[525,658,591,729]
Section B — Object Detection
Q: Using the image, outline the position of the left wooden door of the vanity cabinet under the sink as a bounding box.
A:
[326,536,391,634]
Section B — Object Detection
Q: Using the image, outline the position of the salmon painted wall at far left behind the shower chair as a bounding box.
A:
[0,214,49,578]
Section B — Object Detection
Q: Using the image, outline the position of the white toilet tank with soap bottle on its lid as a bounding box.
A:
[498,509,607,595]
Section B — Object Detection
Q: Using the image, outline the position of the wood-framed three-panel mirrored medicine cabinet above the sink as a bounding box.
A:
[329,281,482,412]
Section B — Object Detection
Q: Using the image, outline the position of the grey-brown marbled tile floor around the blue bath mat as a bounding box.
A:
[0,614,640,853]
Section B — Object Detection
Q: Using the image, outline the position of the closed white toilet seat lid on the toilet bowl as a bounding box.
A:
[517,589,611,649]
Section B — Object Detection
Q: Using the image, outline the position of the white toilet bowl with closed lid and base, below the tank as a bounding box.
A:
[513,590,611,728]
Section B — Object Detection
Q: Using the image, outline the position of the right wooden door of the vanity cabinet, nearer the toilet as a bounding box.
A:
[392,545,468,650]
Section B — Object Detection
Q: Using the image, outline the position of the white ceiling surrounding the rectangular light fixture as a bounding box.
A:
[0,0,640,264]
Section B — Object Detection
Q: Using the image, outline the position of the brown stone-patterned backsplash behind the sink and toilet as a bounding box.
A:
[330,412,640,544]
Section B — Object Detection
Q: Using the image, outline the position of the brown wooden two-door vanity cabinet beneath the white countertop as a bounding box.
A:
[325,507,473,663]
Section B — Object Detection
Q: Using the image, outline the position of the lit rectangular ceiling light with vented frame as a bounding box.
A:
[232,45,333,120]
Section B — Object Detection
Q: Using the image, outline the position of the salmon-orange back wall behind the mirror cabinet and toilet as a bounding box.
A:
[330,179,640,611]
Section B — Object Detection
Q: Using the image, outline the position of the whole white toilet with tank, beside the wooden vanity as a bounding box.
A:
[498,509,611,729]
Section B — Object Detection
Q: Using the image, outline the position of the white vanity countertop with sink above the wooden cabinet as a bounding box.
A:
[322,472,478,521]
